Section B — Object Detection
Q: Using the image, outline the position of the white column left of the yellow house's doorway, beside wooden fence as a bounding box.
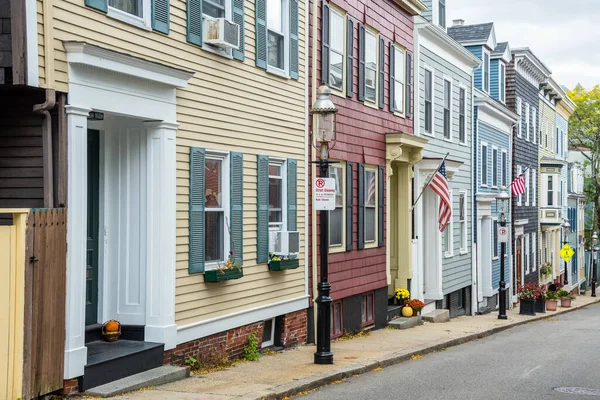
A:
[64,105,91,379]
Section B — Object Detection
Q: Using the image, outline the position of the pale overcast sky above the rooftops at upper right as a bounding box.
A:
[446,0,600,89]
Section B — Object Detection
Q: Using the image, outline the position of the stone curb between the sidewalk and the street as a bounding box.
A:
[255,298,600,400]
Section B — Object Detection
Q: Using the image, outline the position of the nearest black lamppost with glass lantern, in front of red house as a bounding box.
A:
[310,84,338,364]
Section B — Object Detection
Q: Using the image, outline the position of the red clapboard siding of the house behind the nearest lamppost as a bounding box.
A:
[308,0,413,300]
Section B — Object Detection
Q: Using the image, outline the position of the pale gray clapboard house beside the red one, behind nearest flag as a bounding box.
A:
[411,0,480,317]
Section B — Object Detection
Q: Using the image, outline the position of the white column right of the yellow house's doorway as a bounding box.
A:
[144,122,177,350]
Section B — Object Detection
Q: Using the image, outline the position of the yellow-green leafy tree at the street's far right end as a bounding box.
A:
[568,85,600,234]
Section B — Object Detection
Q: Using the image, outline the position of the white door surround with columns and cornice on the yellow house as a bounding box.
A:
[64,42,193,379]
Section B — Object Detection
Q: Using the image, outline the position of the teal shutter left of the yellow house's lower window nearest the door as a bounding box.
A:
[188,147,206,274]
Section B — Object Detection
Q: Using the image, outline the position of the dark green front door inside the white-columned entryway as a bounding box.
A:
[85,129,100,325]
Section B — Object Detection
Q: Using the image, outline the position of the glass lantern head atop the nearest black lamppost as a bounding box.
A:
[309,84,338,160]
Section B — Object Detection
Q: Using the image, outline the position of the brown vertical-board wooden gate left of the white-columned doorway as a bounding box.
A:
[23,208,67,399]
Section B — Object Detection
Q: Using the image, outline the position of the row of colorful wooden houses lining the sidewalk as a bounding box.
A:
[0,0,585,399]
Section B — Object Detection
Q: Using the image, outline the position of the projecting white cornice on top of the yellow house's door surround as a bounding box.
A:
[64,42,194,88]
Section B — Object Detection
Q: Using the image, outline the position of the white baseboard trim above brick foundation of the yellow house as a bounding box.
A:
[177,295,309,345]
